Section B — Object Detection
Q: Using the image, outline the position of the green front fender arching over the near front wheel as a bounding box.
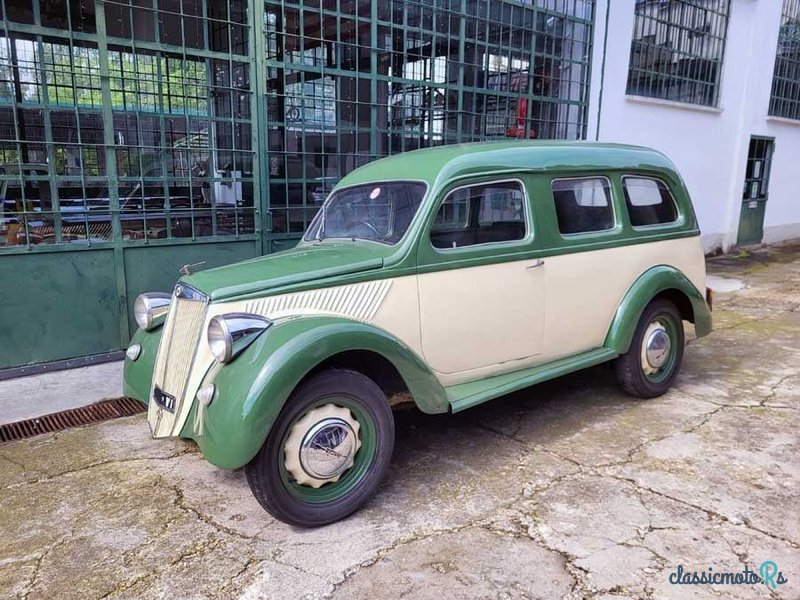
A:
[181,316,449,469]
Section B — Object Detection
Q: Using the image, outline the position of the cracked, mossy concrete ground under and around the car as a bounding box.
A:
[0,245,800,600]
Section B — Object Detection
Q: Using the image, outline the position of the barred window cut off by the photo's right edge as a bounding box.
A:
[769,0,800,119]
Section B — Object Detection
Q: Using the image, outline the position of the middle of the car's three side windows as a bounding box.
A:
[553,177,614,234]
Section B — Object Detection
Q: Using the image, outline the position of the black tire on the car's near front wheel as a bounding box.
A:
[245,369,394,527]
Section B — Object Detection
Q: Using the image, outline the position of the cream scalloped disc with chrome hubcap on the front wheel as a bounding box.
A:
[284,404,361,488]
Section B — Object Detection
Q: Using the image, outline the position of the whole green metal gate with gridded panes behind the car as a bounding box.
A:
[0,0,594,369]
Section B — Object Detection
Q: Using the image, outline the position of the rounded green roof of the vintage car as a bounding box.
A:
[337,140,677,187]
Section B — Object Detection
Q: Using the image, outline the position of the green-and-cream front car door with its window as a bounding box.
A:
[417,179,545,383]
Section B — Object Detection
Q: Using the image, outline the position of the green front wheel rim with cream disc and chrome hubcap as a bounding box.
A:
[278,396,377,504]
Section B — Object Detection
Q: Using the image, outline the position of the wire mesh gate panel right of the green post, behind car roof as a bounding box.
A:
[263,0,594,236]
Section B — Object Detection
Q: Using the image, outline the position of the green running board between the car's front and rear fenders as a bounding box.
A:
[445,348,619,413]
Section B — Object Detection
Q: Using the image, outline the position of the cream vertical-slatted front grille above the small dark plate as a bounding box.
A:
[154,286,207,405]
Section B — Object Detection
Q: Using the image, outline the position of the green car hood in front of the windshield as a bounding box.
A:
[181,240,392,301]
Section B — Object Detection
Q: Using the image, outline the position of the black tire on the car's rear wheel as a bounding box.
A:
[615,299,684,398]
